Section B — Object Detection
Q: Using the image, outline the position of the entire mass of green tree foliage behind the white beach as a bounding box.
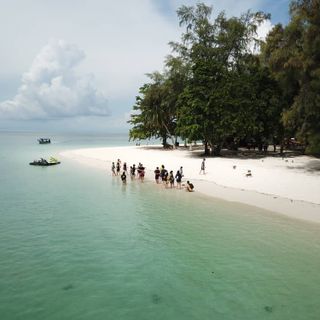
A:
[129,0,320,155]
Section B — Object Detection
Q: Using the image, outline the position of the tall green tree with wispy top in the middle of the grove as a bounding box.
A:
[172,3,274,155]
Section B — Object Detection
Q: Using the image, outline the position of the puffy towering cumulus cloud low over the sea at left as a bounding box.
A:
[0,40,109,119]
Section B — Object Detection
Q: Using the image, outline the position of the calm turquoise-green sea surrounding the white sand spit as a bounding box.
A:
[0,132,320,320]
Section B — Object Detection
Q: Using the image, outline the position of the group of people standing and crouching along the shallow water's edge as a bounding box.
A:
[111,159,194,192]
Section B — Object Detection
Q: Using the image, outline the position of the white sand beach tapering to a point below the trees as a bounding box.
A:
[61,146,320,223]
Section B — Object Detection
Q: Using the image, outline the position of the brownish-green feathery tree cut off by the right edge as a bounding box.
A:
[263,0,320,154]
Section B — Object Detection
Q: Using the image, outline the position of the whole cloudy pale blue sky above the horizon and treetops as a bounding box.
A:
[0,0,290,133]
